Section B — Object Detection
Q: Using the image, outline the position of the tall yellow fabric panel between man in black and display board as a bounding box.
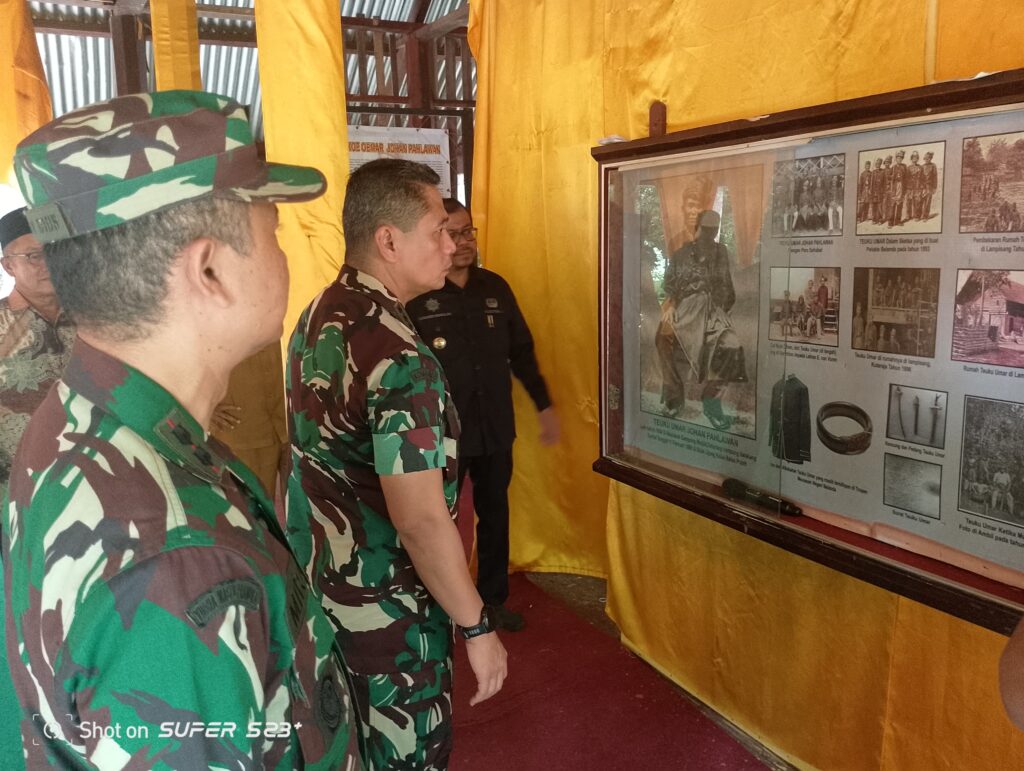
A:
[469,0,607,574]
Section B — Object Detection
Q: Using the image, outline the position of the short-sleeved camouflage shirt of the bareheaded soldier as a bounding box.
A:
[286,266,459,674]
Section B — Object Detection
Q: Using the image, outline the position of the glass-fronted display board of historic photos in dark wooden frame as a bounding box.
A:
[593,71,1024,633]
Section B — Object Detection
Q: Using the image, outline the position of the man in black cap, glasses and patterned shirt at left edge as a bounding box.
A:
[0,209,75,499]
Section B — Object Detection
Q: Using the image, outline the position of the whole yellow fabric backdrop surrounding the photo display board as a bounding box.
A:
[470,0,1024,771]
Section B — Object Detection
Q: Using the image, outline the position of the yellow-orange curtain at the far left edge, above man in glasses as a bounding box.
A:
[0,0,53,187]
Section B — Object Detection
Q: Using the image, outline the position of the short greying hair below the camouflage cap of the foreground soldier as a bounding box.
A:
[45,197,252,342]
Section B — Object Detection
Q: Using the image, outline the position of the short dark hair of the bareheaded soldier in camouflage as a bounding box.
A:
[341,158,440,263]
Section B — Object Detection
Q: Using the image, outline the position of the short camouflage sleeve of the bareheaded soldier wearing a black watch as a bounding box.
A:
[367,351,446,475]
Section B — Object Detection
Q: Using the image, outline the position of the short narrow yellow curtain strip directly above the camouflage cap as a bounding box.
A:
[150,0,203,91]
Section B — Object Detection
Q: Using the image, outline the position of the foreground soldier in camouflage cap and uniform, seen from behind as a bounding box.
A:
[2,91,360,770]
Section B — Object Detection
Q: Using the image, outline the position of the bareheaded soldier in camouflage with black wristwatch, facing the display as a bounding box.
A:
[287,159,506,771]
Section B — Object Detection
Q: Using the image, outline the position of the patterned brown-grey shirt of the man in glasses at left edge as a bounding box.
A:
[0,291,75,498]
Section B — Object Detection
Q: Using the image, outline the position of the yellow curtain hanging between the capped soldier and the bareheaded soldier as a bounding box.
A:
[256,0,348,339]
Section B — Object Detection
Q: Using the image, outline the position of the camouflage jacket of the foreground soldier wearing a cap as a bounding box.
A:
[2,340,359,769]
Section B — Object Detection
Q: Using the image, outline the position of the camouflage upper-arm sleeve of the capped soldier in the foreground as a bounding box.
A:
[53,548,293,769]
